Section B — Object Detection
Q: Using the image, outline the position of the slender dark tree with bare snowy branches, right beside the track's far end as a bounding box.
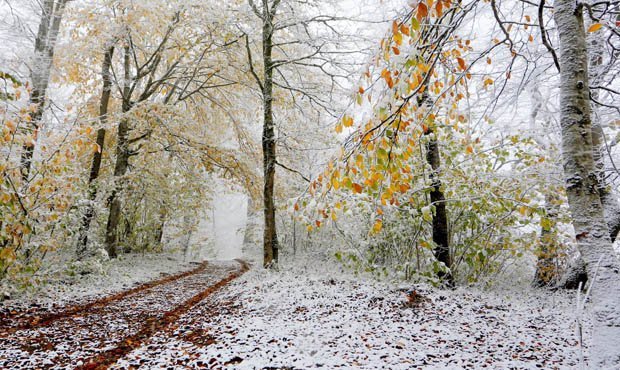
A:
[244,0,359,267]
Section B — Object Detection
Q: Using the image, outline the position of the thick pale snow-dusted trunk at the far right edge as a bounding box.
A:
[554,0,620,368]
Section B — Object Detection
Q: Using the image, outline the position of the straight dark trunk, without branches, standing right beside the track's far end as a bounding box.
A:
[262,0,279,267]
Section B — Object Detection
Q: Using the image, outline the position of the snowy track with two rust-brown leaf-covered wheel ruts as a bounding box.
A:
[0,262,247,369]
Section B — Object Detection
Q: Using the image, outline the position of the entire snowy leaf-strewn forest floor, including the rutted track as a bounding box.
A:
[0,261,587,369]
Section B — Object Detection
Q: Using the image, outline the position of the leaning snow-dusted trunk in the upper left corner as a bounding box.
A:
[20,0,67,179]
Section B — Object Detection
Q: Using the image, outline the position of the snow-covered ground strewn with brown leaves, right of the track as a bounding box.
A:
[116,260,587,369]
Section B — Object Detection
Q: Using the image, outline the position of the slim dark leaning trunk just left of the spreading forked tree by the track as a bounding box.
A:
[105,46,131,258]
